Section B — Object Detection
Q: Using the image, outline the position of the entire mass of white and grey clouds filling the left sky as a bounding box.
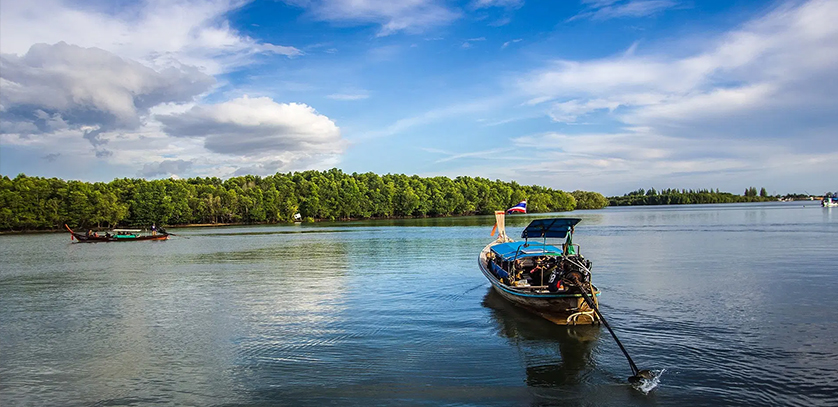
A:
[0,0,334,177]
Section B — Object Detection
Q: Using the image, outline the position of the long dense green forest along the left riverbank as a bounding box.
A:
[0,169,607,230]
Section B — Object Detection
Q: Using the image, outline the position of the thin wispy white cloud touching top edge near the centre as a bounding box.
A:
[285,0,460,36]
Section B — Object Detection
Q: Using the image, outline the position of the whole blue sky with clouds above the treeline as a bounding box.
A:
[0,0,838,195]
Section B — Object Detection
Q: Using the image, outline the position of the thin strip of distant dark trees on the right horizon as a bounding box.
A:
[608,187,777,206]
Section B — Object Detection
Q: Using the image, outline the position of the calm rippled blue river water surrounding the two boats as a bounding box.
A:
[0,202,838,407]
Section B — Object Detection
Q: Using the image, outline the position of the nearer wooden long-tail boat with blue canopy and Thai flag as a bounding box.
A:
[477,211,600,325]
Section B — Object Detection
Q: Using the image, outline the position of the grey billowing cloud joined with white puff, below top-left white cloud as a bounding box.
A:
[0,43,346,177]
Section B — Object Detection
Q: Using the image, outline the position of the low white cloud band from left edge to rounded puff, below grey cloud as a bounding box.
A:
[0,98,347,177]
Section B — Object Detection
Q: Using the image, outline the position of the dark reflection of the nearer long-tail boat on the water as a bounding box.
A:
[483,289,600,387]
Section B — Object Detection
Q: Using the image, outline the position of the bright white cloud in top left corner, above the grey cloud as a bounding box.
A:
[0,0,302,74]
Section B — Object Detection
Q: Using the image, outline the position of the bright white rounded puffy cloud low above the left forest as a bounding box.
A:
[156,96,345,156]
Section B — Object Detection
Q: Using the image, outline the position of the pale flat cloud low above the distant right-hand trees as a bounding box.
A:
[480,128,834,195]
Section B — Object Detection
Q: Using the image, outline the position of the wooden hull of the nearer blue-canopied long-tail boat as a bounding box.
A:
[478,243,600,325]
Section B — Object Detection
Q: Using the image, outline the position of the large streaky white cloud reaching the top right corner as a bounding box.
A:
[519,1,838,142]
